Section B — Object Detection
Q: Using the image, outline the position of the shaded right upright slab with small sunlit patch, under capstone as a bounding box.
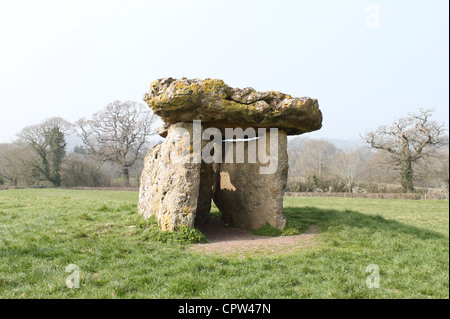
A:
[214,130,288,229]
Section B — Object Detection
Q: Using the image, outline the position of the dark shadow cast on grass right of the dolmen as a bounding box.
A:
[284,206,447,240]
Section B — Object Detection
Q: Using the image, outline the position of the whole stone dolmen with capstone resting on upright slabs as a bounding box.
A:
[138,78,322,231]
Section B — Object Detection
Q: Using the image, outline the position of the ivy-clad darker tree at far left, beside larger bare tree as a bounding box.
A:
[18,117,72,186]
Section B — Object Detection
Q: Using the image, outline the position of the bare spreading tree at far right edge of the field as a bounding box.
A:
[361,109,448,192]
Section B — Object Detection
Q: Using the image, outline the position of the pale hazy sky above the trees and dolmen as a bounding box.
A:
[0,0,449,142]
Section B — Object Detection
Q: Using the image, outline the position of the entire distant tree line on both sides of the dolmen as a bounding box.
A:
[0,107,449,193]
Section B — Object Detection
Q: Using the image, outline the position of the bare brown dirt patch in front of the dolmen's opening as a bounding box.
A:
[190,218,320,257]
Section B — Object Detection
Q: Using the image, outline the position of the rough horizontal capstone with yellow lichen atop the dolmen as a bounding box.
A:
[144,78,322,135]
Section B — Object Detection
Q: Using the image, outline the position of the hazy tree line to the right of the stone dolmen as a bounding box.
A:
[287,110,449,193]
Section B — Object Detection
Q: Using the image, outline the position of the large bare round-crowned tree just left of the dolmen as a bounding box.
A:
[76,101,156,186]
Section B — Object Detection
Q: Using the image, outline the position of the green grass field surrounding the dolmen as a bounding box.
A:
[0,189,449,298]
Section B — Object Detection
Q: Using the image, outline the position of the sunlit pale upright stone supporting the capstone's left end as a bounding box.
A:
[138,122,201,231]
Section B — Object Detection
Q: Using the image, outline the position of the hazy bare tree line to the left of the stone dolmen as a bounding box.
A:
[0,101,155,187]
